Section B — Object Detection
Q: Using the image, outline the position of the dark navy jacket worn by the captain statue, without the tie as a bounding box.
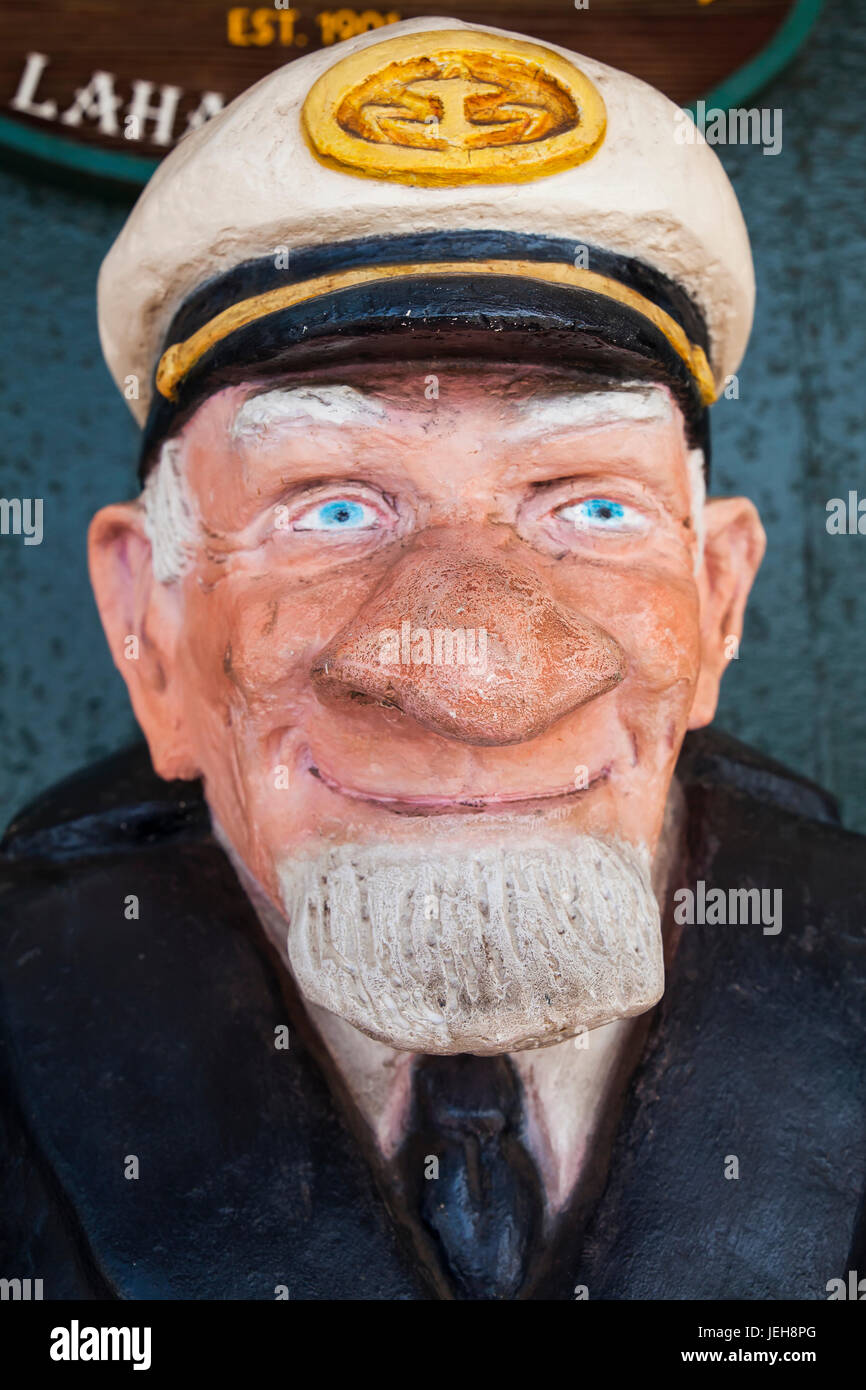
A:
[0,733,866,1300]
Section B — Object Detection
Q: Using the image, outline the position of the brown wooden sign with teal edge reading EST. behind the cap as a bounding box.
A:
[0,0,820,183]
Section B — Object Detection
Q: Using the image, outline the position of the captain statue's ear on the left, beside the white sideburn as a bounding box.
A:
[88,502,199,781]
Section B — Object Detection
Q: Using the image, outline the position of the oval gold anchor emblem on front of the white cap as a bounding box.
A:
[302,29,606,185]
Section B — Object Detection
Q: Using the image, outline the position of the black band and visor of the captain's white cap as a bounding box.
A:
[140,232,709,480]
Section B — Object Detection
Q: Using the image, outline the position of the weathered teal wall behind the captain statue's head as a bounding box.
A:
[0,0,866,831]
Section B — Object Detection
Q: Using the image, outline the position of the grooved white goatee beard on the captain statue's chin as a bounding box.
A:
[279,835,664,1054]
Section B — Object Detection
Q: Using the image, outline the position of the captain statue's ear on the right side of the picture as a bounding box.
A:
[688,498,767,728]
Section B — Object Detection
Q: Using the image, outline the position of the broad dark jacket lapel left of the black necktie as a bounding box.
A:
[6,840,428,1300]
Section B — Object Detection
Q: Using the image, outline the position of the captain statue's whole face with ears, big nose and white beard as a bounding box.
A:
[92,363,763,1052]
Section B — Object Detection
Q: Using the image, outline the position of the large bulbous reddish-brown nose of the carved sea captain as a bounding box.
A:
[313,542,626,745]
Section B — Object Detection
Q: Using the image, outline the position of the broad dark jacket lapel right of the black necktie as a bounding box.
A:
[534,784,866,1300]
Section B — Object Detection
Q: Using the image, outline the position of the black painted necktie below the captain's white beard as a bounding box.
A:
[403,1054,542,1298]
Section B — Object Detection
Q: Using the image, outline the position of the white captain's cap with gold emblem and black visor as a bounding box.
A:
[99,18,755,471]
